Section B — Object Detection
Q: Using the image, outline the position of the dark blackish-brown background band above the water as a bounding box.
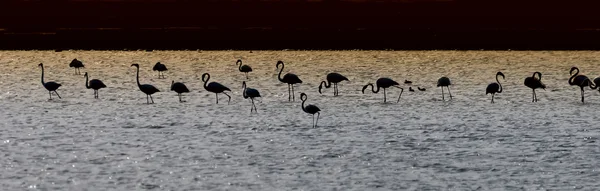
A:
[0,0,600,50]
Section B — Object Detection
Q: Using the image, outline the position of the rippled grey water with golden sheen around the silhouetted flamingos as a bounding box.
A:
[0,51,600,190]
